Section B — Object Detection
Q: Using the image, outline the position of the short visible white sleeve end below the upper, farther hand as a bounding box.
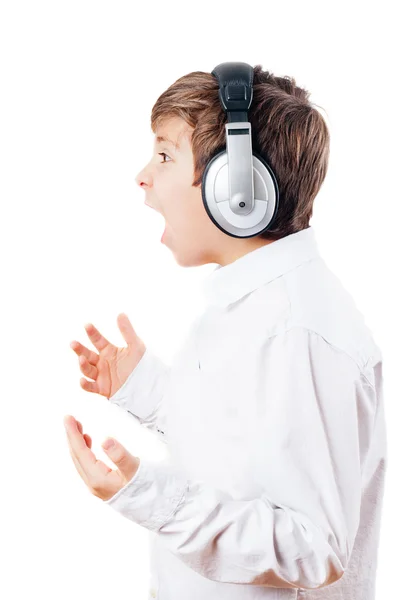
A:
[108,347,171,443]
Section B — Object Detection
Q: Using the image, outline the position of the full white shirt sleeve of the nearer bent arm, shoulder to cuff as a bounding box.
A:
[106,327,375,589]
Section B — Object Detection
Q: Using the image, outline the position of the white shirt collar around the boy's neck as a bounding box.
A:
[202,226,320,307]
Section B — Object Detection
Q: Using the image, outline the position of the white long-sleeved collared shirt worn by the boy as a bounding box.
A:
[106,227,387,600]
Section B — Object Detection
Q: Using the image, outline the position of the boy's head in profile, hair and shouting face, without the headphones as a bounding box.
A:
[136,65,330,266]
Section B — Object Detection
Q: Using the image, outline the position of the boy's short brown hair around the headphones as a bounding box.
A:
[151,65,330,240]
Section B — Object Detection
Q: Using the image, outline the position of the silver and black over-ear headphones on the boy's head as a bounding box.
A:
[201,62,279,238]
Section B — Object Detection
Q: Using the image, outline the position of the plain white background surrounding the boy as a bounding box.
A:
[0,0,399,600]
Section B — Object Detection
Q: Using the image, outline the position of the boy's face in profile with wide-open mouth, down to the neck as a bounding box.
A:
[136,117,269,267]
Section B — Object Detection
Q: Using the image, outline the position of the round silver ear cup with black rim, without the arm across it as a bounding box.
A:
[202,150,279,238]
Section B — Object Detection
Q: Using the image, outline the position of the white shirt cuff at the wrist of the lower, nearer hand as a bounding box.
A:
[104,458,189,531]
